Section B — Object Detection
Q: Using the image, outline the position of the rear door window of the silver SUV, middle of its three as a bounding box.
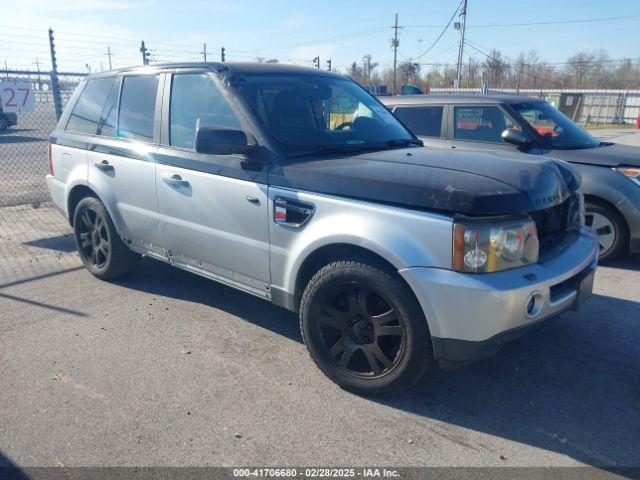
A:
[117,75,158,142]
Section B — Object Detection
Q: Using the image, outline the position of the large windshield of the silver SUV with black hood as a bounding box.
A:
[234,73,420,157]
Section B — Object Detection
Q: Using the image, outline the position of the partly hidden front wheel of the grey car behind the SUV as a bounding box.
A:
[585,202,629,262]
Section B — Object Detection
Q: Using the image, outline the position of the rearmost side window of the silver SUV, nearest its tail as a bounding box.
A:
[66,78,113,135]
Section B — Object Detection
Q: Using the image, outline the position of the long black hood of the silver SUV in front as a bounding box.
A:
[269,147,579,215]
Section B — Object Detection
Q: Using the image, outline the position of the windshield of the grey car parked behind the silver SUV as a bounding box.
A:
[511,102,600,150]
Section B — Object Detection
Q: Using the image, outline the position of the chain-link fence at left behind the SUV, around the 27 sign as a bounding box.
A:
[0,72,82,287]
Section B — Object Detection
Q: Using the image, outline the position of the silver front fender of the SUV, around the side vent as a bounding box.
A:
[269,188,452,294]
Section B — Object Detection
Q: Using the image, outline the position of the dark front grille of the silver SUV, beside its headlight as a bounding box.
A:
[529,193,582,257]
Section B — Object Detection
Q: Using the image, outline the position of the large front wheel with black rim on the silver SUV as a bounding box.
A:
[300,260,433,395]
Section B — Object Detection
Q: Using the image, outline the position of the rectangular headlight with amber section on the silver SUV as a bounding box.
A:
[453,217,539,273]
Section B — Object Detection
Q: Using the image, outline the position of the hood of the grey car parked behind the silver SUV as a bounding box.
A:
[549,143,640,167]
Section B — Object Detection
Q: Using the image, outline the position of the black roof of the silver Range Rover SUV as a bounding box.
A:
[88,62,340,78]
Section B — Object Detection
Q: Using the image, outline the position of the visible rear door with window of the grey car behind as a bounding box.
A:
[393,105,446,148]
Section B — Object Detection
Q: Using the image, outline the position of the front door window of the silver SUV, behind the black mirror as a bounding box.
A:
[169,73,241,148]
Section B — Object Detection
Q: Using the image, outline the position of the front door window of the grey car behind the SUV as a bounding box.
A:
[453,106,514,143]
